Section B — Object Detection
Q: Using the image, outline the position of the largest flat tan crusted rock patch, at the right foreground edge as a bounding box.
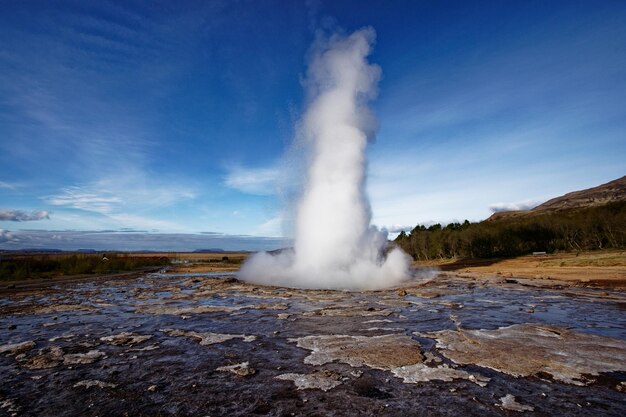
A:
[421,323,626,385]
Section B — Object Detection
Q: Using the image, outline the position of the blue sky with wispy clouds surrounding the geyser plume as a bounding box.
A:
[0,0,626,250]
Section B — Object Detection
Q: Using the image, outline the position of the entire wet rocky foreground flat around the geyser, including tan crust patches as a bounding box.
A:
[0,273,626,416]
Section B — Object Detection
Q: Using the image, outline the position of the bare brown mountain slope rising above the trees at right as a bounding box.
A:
[487,175,626,221]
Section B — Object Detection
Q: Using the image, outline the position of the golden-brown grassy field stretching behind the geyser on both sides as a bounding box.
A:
[0,250,626,286]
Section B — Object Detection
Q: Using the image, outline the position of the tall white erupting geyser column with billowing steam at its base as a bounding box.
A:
[240,28,409,289]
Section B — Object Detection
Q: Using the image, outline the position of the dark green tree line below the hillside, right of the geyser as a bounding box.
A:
[395,201,626,260]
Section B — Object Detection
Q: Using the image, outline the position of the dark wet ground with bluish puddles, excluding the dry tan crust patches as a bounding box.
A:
[0,273,626,416]
